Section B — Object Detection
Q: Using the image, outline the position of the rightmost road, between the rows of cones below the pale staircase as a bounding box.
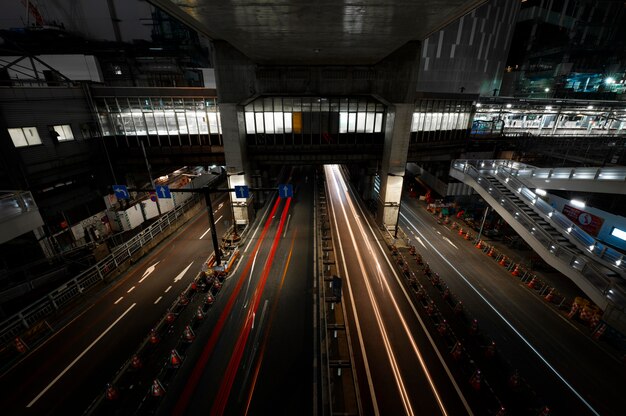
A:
[400,198,626,415]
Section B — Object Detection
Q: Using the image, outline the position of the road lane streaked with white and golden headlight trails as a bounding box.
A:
[325,166,472,415]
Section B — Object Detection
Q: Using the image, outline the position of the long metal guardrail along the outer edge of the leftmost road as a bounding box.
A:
[0,196,201,345]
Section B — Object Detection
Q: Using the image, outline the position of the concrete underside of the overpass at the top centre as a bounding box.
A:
[150,0,486,65]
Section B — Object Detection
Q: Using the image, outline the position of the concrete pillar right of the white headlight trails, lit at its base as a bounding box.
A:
[377,104,415,231]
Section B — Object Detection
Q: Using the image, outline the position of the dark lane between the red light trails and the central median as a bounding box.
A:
[229,168,316,416]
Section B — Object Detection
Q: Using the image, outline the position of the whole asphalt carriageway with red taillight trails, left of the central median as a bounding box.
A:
[158,168,314,415]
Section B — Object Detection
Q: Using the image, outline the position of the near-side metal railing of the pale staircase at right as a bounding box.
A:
[451,160,626,307]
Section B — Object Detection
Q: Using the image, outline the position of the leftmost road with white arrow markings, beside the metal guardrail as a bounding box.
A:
[0,193,230,414]
